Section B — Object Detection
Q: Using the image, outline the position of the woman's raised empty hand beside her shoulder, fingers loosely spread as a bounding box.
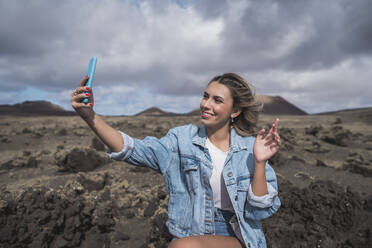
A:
[253,118,280,163]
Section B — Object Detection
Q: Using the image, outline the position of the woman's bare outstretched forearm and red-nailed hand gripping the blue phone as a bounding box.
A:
[71,76,124,152]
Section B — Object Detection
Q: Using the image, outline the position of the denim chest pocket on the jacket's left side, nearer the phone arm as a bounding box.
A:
[181,158,200,193]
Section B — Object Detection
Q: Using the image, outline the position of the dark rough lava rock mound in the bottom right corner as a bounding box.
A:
[263,181,372,247]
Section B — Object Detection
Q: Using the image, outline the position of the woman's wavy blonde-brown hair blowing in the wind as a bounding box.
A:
[208,72,263,136]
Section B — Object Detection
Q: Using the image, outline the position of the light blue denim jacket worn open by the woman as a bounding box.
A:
[107,124,280,247]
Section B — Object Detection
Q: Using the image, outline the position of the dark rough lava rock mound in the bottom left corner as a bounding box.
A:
[0,187,113,247]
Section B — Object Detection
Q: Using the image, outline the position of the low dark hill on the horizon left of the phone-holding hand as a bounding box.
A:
[0,101,76,116]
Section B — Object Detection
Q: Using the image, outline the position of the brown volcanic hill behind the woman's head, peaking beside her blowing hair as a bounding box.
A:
[186,95,307,115]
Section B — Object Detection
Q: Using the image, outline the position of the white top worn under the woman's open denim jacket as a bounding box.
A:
[205,138,234,211]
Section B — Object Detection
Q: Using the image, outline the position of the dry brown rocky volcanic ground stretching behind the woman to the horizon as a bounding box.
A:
[0,111,372,248]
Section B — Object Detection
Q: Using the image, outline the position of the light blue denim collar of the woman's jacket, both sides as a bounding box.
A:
[192,125,249,152]
